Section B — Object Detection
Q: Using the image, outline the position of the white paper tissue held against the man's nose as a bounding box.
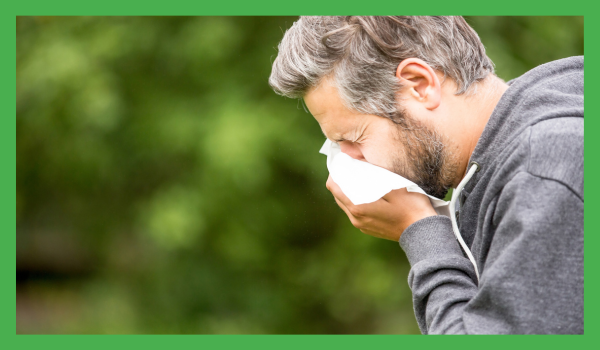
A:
[319,139,450,216]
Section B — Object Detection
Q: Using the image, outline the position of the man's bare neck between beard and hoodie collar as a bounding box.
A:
[454,74,508,187]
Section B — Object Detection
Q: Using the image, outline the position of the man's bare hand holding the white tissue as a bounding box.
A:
[326,176,437,242]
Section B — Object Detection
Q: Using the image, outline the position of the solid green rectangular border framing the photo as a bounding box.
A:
[5,0,600,349]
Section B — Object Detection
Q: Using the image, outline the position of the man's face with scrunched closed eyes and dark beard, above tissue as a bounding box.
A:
[304,82,456,198]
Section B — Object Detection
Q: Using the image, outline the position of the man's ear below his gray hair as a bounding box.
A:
[396,58,442,110]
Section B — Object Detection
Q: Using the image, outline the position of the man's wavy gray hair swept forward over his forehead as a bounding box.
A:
[269,16,494,120]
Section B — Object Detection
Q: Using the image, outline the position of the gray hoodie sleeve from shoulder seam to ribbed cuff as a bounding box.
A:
[400,172,583,334]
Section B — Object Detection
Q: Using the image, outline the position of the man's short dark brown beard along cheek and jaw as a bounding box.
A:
[390,111,458,199]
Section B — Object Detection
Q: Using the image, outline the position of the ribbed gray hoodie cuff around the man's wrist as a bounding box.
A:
[400,215,463,266]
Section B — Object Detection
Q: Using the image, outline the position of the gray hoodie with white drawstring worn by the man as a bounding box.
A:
[400,57,583,334]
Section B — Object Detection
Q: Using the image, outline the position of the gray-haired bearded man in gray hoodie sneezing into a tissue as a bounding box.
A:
[269,16,583,334]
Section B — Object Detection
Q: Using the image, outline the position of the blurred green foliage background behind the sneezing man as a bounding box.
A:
[16,17,583,334]
